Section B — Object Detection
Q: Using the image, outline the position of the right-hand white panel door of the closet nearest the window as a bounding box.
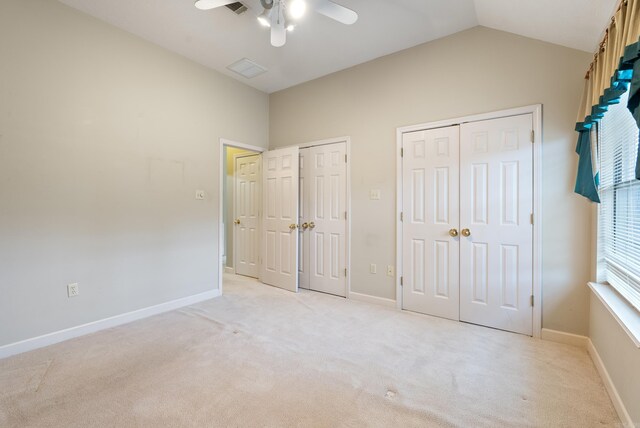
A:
[460,114,533,335]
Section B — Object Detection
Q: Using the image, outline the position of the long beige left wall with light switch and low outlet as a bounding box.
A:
[0,0,268,345]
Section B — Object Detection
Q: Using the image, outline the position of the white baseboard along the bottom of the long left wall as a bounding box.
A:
[0,289,220,359]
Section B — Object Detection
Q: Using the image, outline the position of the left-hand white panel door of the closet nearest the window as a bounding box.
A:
[402,126,459,320]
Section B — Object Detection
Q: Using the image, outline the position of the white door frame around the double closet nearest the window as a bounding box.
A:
[395,104,542,338]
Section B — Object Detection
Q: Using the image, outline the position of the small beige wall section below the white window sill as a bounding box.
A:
[589,293,640,426]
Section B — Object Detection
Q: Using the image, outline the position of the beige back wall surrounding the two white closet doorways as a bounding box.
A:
[269,27,591,335]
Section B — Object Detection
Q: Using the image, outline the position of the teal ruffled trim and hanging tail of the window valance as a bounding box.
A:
[575,41,640,202]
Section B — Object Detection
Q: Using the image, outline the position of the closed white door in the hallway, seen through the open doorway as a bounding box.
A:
[233,155,262,278]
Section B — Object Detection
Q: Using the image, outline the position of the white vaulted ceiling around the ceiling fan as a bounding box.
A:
[60,0,618,93]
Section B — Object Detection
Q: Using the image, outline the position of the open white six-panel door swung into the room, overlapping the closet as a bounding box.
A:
[260,147,298,292]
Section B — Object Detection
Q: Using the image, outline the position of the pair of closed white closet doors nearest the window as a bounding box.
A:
[402,114,533,335]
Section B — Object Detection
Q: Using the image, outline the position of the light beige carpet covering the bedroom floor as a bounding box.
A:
[0,276,620,427]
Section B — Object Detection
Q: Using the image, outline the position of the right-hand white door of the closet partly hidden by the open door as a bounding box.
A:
[305,143,347,297]
